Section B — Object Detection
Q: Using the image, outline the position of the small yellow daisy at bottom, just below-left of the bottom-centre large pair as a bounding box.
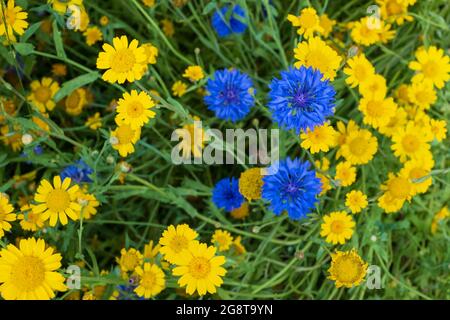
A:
[134,262,166,299]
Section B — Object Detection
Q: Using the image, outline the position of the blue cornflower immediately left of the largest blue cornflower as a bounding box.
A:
[204,69,255,122]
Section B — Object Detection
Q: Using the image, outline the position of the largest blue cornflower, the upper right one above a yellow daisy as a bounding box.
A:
[268,66,336,134]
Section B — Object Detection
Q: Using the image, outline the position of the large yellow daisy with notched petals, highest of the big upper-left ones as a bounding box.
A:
[97,36,148,83]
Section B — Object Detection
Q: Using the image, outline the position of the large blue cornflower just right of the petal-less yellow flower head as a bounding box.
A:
[262,158,322,220]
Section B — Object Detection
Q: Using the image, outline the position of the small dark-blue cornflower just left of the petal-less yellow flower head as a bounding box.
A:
[212,178,244,212]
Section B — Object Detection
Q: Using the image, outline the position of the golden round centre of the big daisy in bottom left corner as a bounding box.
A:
[11,256,45,292]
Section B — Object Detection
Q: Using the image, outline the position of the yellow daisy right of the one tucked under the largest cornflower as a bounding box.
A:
[341,129,378,164]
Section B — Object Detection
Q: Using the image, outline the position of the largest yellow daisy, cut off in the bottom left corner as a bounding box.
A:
[0,238,67,300]
